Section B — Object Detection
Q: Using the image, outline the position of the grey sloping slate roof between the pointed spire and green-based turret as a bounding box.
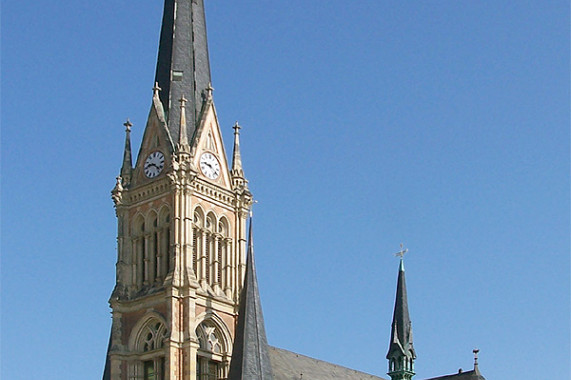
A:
[269,347,384,380]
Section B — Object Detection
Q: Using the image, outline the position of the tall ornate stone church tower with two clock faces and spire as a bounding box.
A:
[103,0,252,380]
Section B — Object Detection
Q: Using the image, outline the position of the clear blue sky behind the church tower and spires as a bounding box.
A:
[1,0,570,380]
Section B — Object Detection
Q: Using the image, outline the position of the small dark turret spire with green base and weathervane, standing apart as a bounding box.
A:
[387,257,416,380]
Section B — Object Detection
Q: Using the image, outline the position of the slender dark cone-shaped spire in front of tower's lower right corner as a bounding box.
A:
[228,218,273,380]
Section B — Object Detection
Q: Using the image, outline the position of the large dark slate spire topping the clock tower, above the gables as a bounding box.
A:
[155,0,211,142]
